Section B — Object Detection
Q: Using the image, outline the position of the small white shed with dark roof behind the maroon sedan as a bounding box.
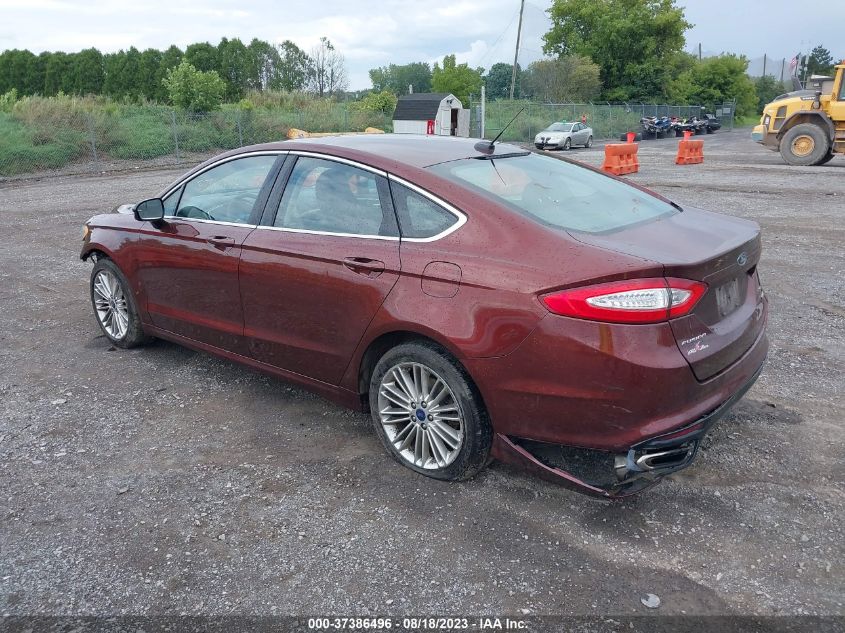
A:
[393,92,469,136]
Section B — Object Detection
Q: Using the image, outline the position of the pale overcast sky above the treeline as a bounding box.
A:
[0,0,845,89]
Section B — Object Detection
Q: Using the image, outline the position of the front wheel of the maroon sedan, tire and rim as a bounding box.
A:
[91,259,150,349]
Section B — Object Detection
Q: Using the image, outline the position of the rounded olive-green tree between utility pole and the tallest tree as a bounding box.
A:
[522,55,601,103]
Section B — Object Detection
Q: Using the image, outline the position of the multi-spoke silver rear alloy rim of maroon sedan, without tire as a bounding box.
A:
[378,362,464,470]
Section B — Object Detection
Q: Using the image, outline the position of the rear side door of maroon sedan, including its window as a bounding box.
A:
[234,155,400,384]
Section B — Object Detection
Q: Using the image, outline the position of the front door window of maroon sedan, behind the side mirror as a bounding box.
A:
[175,156,277,224]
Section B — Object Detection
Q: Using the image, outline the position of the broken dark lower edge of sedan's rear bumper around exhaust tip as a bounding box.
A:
[493,365,763,499]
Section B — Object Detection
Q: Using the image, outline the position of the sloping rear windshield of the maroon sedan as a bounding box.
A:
[429,154,678,233]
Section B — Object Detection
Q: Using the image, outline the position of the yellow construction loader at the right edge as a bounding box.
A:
[751,60,845,165]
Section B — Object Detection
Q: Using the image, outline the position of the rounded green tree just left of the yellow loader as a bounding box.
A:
[669,55,758,116]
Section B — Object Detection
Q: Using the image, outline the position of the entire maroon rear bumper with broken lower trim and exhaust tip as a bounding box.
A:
[468,316,768,497]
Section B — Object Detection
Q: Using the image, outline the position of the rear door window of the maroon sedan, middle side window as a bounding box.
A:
[273,156,396,237]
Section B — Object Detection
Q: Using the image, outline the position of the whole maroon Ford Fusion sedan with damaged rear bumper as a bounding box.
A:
[82,135,768,497]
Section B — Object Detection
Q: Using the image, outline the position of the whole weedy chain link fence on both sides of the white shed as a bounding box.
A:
[0,99,733,180]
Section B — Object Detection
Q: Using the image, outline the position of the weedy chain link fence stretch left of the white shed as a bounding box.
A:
[0,99,392,180]
